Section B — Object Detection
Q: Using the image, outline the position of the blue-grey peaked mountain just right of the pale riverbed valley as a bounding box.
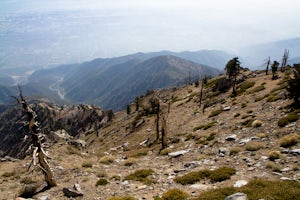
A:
[65,56,220,110]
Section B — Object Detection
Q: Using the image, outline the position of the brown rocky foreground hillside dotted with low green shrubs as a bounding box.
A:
[0,70,300,200]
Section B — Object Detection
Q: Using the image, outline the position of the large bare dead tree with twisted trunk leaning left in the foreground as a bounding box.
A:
[13,86,57,188]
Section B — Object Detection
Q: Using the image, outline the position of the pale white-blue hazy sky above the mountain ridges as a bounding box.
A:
[0,0,300,65]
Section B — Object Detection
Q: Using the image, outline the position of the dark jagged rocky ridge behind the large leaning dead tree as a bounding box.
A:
[0,101,113,158]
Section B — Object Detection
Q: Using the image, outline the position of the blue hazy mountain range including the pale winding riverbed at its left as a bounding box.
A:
[3,52,220,110]
